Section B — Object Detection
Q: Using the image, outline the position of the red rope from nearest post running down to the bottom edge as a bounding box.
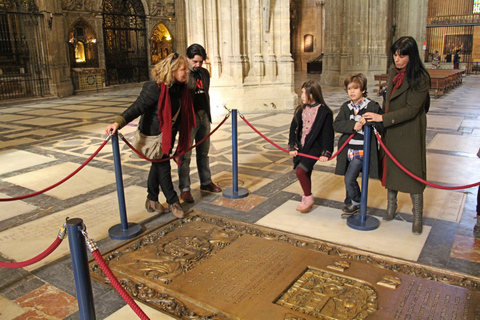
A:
[82,229,150,320]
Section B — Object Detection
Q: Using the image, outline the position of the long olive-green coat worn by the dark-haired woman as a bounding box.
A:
[382,66,430,193]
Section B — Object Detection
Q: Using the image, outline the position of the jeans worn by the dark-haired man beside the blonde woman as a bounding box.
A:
[178,111,212,192]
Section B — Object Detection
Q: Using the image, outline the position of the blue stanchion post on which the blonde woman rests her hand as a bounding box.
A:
[108,131,142,240]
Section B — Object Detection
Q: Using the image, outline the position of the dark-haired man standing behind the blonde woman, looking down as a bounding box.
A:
[178,43,222,203]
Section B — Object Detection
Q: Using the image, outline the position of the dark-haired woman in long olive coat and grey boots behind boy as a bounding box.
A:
[365,37,430,234]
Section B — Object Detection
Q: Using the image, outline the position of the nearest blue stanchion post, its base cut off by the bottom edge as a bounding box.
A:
[67,218,96,320]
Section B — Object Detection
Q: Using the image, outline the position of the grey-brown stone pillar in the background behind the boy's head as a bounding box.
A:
[321,0,390,86]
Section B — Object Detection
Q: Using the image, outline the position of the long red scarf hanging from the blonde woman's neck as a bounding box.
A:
[158,83,196,164]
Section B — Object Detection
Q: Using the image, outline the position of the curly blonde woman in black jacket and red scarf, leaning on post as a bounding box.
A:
[105,53,195,218]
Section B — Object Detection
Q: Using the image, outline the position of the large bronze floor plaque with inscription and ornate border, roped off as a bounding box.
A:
[90,211,480,320]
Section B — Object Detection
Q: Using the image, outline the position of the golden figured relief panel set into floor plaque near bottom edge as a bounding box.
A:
[275,268,378,320]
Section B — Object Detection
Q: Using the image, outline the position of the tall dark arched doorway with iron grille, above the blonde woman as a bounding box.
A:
[103,0,148,85]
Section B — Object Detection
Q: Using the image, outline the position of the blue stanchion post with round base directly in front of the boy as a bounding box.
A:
[347,124,380,231]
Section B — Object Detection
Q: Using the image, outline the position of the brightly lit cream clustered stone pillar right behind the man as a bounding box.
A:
[185,0,297,112]
